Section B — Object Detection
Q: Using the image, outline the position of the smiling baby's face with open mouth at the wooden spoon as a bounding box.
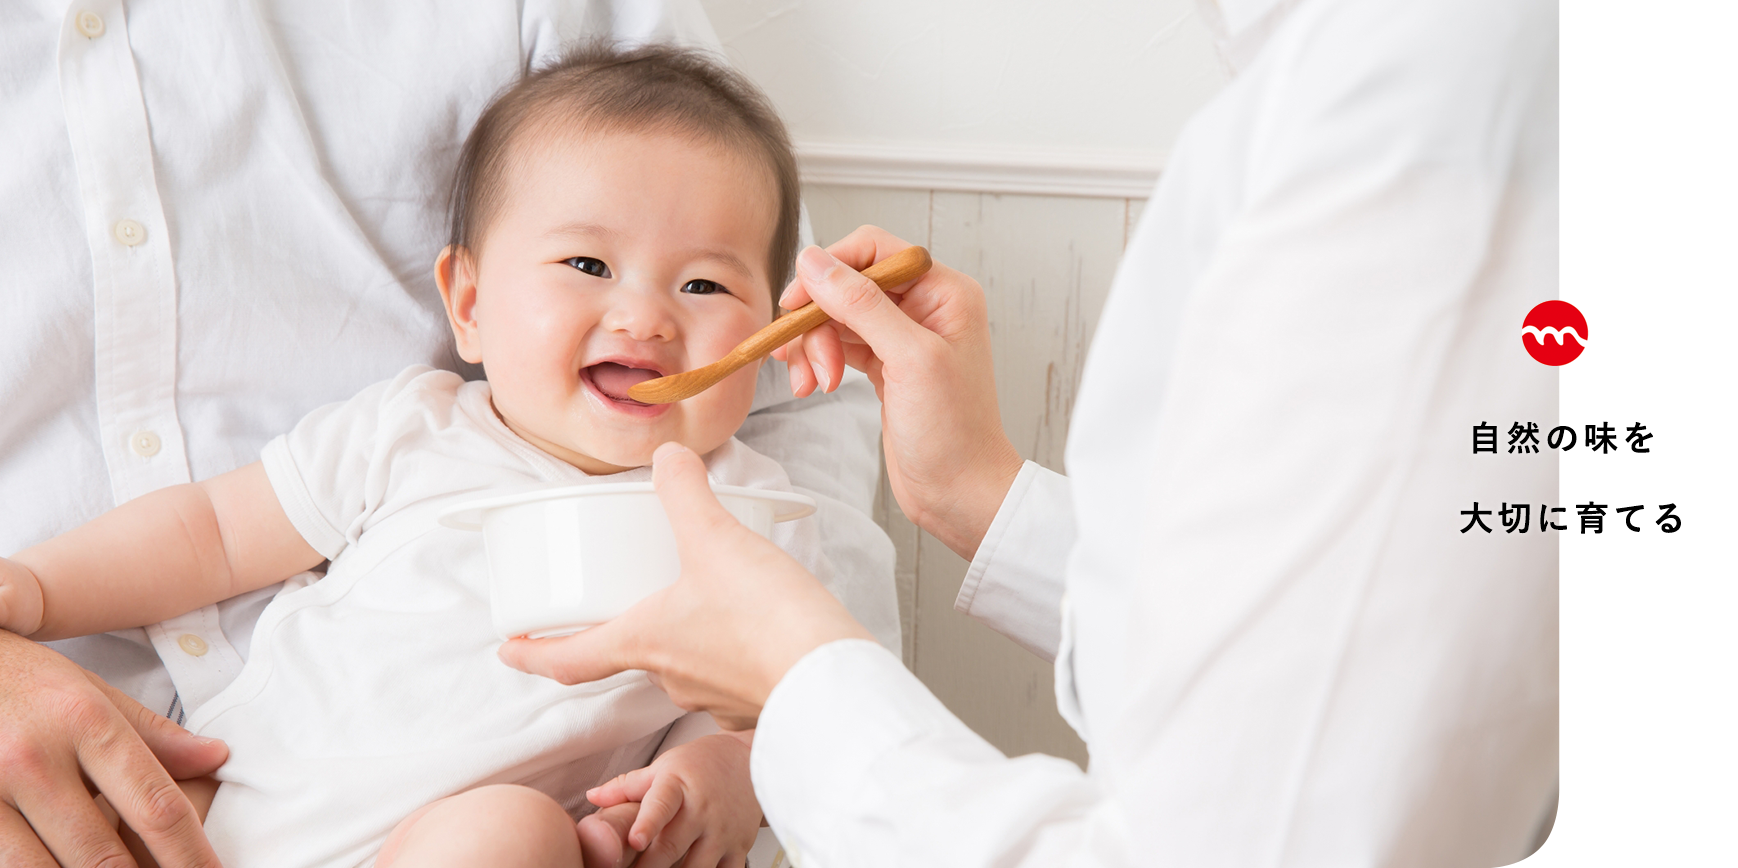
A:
[436,132,777,473]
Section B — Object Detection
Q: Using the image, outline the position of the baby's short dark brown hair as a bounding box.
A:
[450,42,801,297]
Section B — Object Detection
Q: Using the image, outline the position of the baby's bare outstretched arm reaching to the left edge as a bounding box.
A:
[0,461,325,642]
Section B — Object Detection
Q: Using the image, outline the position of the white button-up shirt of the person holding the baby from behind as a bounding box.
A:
[13,0,899,718]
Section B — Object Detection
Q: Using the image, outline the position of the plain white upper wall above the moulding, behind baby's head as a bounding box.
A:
[702,0,1224,195]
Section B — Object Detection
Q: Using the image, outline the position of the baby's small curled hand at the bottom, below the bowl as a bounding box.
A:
[579,734,761,868]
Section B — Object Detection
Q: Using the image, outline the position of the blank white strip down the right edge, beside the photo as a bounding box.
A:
[1562,0,1738,866]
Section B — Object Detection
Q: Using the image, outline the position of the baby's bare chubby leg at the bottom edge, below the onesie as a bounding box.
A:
[375,785,580,868]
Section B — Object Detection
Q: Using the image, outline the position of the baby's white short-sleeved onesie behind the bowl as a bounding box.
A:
[188,367,839,868]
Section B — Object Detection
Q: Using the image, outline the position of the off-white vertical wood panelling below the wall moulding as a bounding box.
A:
[803,184,1144,765]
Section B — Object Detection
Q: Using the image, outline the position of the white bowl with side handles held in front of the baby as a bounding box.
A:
[440,482,815,638]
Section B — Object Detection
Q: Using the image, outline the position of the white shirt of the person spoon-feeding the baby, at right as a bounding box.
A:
[753,0,1559,868]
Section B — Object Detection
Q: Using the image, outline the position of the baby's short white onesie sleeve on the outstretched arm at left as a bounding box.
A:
[261,365,464,558]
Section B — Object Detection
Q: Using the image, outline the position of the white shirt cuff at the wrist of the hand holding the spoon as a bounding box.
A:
[954,461,1074,663]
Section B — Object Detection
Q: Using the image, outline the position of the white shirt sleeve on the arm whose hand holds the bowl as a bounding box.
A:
[749,638,1135,868]
